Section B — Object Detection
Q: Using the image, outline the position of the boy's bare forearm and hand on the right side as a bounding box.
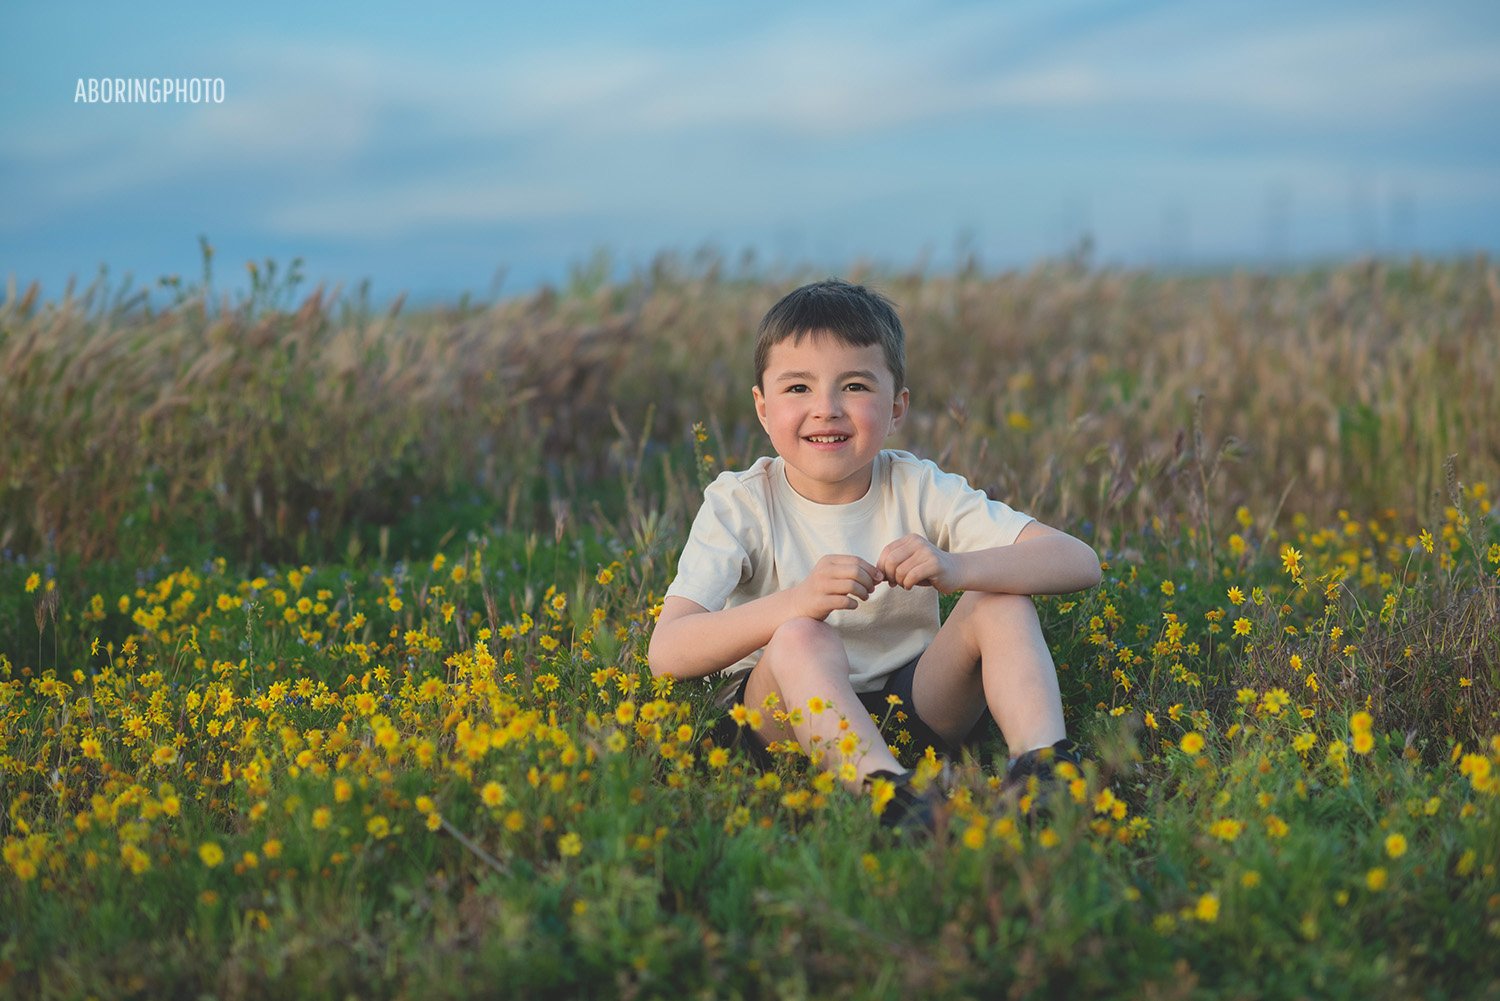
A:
[876,521,1101,594]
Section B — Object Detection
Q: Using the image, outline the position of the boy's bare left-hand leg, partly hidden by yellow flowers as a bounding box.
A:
[746,618,902,789]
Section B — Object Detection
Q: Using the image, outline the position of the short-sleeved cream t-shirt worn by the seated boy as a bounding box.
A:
[666,449,1032,702]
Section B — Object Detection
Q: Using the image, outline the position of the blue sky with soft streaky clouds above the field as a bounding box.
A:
[0,0,1500,299]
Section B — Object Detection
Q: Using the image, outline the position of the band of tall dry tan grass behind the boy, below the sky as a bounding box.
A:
[0,258,1500,557]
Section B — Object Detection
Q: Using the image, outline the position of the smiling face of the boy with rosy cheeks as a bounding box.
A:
[750,333,908,504]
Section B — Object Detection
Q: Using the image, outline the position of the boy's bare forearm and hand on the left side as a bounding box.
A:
[647,555,881,678]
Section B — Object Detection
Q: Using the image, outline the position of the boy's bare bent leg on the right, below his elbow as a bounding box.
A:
[912,591,1068,755]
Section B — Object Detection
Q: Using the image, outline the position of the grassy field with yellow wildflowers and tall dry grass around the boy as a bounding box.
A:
[0,257,1500,998]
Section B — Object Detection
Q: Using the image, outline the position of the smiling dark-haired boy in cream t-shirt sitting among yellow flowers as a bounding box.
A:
[648,279,1100,824]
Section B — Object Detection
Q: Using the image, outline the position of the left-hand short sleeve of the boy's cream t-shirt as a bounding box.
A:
[666,473,761,612]
